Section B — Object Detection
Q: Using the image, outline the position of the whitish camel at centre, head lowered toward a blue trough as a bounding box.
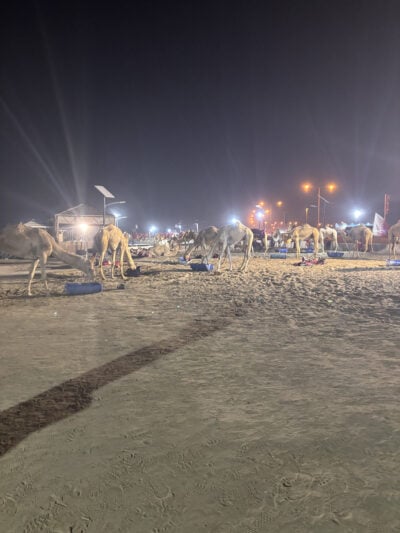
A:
[205,222,254,272]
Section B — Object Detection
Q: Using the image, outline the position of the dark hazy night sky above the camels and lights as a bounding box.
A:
[0,0,400,229]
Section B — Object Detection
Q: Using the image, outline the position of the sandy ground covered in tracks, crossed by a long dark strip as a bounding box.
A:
[0,257,400,533]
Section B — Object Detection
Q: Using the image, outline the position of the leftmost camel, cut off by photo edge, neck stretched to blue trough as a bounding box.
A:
[0,224,94,296]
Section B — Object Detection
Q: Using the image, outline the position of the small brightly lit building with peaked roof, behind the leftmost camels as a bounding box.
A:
[54,204,115,252]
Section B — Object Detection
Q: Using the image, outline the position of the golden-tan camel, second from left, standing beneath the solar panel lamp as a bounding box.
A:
[90,224,136,279]
